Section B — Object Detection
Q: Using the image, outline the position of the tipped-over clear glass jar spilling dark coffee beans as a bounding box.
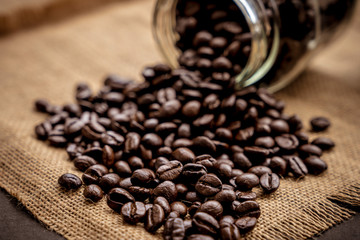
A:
[153,0,356,92]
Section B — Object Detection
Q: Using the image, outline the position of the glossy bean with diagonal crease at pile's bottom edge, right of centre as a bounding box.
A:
[193,212,220,235]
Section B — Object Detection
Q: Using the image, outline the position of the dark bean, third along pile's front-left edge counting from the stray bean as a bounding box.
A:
[107,188,135,212]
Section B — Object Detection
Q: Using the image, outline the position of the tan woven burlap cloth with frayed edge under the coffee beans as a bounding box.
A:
[0,0,360,240]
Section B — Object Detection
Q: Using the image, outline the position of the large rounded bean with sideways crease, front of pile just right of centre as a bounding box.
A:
[195,174,222,196]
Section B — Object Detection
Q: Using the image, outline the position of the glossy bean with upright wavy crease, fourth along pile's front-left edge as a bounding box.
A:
[121,202,146,224]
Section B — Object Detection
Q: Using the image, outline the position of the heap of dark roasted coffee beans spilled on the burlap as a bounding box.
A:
[35,61,334,239]
